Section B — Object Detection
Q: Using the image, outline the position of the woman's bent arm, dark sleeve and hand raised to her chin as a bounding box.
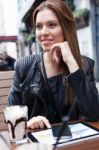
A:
[51,41,99,120]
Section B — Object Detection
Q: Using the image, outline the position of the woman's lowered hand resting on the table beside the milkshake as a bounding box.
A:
[27,116,51,129]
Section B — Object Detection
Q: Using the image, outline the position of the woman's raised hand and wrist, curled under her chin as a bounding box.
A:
[50,41,79,73]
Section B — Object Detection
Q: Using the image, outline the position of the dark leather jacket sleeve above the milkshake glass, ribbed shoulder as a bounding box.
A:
[8,56,36,105]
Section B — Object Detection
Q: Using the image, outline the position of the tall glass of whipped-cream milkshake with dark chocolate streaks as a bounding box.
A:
[4,105,28,144]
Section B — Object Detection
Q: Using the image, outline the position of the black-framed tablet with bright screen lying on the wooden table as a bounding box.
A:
[28,122,99,145]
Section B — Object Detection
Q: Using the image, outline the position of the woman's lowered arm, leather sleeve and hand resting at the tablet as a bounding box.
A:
[8,55,51,129]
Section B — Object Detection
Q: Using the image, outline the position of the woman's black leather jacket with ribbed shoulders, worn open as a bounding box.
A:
[8,56,99,123]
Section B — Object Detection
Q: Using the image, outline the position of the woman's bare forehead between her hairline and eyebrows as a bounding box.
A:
[36,8,58,23]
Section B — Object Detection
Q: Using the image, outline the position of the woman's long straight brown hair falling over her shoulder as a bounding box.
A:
[33,0,82,103]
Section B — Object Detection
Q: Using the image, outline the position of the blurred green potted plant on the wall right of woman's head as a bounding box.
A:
[73,8,89,29]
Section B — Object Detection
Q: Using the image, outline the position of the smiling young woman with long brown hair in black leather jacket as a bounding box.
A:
[8,0,99,129]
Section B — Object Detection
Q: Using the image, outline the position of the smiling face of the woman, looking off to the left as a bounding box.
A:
[36,8,64,51]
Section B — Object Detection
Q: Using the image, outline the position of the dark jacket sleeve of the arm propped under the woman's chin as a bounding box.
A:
[68,58,99,121]
